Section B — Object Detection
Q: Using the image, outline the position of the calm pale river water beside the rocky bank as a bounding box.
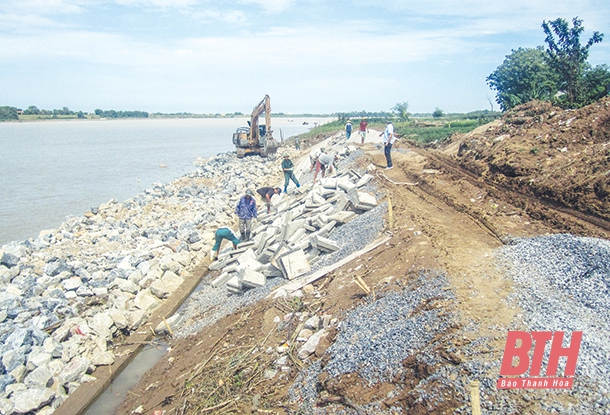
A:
[0,118,329,246]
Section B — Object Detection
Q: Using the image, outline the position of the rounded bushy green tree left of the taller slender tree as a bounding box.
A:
[487,46,558,111]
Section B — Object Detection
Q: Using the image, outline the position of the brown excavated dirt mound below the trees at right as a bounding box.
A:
[442,97,610,220]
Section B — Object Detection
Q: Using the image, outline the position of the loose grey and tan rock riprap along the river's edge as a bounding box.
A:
[0,153,290,414]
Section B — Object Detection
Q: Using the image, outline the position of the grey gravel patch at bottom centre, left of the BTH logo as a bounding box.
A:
[290,271,467,414]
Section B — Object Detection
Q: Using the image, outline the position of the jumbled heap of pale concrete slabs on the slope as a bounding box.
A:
[209,170,377,294]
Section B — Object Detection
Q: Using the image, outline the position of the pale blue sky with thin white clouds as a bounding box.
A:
[0,0,610,113]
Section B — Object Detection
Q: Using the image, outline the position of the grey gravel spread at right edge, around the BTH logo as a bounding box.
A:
[499,234,610,414]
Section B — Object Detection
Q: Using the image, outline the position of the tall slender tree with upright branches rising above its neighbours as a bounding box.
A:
[542,17,604,107]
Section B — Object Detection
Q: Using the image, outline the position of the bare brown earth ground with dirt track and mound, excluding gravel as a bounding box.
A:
[117,101,610,415]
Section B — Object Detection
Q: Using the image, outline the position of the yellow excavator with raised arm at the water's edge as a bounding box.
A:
[233,95,279,158]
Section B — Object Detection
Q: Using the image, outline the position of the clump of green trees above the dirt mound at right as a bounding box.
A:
[487,18,610,111]
